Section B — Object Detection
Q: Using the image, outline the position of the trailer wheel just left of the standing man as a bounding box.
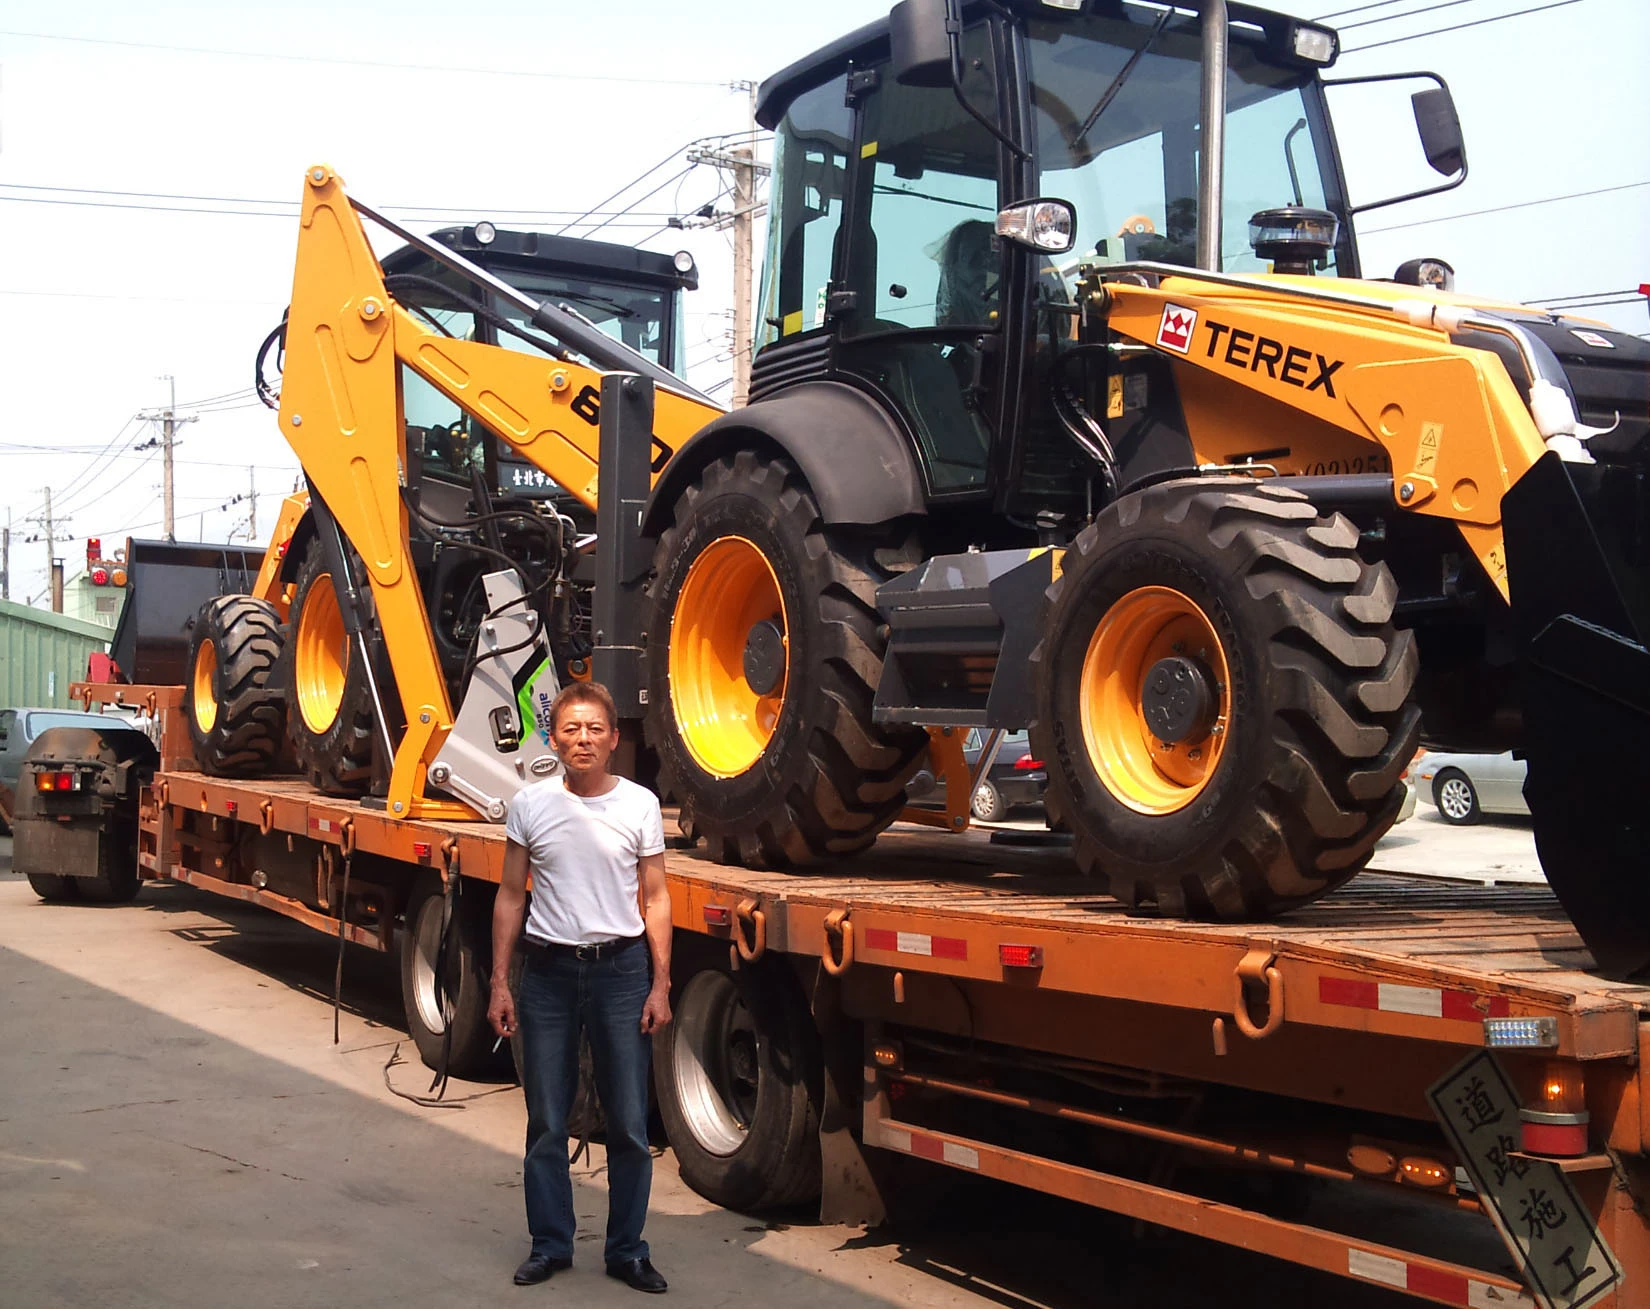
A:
[401,875,510,1078]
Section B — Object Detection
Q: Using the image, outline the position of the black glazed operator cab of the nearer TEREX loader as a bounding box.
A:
[751,0,1447,531]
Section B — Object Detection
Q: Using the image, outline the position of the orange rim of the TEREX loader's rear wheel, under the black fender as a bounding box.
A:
[670,536,790,777]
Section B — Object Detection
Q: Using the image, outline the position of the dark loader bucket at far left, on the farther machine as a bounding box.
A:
[109,541,264,687]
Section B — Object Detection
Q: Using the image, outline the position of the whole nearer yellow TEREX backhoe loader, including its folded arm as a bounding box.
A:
[199,0,1650,974]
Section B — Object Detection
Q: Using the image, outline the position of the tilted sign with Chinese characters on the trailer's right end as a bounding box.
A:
[1427,1050,1622,1309]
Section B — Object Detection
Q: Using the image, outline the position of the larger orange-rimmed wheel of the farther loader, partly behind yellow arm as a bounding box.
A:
[292,536,376,796]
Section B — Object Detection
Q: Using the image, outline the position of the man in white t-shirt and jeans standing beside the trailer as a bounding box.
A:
[487,682,670,1291]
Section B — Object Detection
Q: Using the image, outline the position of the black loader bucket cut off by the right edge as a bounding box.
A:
[1502,454,1650,977]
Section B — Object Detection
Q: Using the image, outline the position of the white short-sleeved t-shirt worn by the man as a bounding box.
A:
[505,777,665,946]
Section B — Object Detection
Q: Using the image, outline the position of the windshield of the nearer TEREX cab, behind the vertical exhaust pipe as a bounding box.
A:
[1028,3,1345,274]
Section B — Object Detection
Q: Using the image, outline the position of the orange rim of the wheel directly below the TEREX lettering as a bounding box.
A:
[1077,586,1231,814]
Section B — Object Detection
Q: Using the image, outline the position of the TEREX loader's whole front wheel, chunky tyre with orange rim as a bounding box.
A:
[1031,479,1421,919]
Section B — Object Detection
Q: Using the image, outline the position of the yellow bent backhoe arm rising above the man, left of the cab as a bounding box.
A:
[281,167,721,819]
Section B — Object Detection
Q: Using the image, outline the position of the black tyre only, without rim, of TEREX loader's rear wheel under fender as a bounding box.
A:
[647,451,927,867]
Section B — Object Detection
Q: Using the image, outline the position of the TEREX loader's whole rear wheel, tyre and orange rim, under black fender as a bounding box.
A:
[647,451,927,867]
